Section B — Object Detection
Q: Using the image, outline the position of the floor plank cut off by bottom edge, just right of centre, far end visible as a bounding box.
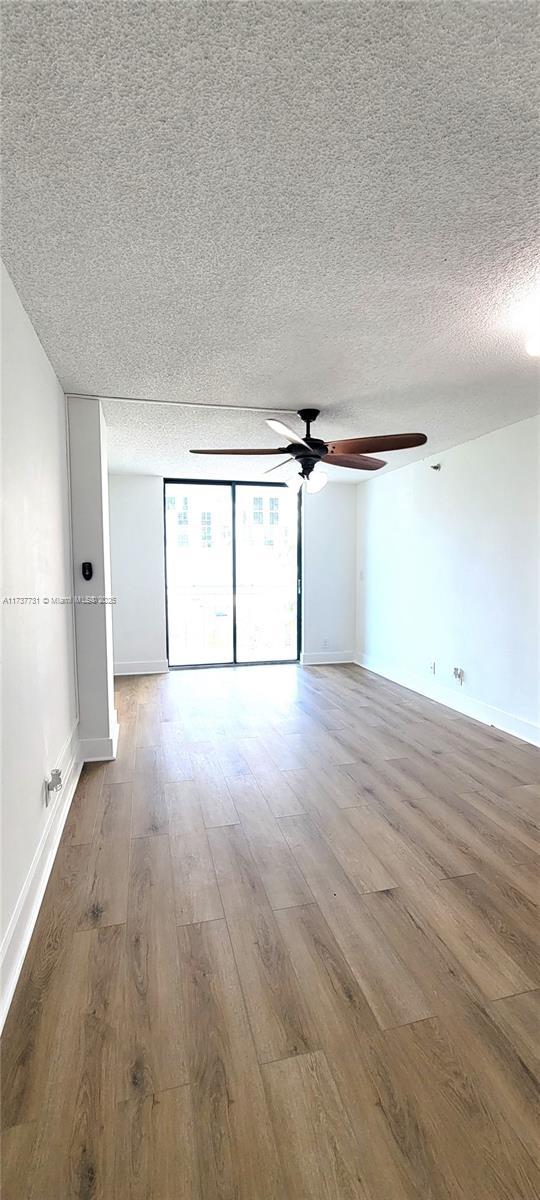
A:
[263,1050,368,1200]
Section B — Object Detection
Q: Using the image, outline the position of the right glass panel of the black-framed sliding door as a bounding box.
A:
[235,484,298,662]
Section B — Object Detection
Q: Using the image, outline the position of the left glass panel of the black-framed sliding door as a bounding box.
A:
[164,481,234,666]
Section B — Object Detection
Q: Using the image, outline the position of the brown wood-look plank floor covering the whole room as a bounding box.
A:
[2,666,540,1200]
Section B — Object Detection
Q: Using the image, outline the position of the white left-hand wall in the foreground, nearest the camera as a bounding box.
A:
[0,268,79,1016]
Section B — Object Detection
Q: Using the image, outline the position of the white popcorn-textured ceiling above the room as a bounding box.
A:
[2,0,539,475]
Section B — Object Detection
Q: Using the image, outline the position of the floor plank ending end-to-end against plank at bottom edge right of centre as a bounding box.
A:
[209,826,318,1062]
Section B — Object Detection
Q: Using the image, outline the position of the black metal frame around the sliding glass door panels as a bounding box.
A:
[163,475,302,671]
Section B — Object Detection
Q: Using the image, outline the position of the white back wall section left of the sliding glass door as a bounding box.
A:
[109,475,168,674]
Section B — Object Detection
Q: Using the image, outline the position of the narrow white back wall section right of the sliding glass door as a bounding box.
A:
[302,484,358,664]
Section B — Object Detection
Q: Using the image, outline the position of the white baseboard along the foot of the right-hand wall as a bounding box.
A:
[353,655,540,746]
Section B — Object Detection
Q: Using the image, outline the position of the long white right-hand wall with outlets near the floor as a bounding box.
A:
[356,418,540,740]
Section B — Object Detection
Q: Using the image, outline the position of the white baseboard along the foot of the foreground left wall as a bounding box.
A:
[0,727,83,1030]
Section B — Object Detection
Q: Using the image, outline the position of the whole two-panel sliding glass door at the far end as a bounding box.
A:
[164,479,300,667]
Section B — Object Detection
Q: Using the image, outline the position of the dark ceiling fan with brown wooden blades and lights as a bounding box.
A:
[190,408,427,492]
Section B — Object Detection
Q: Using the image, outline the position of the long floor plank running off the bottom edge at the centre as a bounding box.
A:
[178,920,286,1200]
